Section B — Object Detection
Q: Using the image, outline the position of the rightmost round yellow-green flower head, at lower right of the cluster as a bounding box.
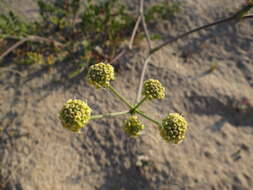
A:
[160,113,188,144]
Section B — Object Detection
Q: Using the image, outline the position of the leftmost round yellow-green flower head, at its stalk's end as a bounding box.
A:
[60,99,91,132]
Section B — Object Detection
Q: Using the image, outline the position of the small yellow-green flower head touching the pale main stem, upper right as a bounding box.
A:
[142,79,165,99]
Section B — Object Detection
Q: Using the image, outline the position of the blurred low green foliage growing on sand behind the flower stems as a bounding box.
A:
[0,0,182,78]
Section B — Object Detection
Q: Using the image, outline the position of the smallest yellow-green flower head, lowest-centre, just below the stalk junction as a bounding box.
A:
[123,116,144,137]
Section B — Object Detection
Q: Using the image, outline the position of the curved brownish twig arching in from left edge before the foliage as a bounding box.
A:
[0,36,63,61]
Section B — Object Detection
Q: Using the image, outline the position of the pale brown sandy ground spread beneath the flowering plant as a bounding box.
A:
[0,0,253,190]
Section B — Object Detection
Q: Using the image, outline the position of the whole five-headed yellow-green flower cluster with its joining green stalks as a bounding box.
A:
[60,63,187,144]
